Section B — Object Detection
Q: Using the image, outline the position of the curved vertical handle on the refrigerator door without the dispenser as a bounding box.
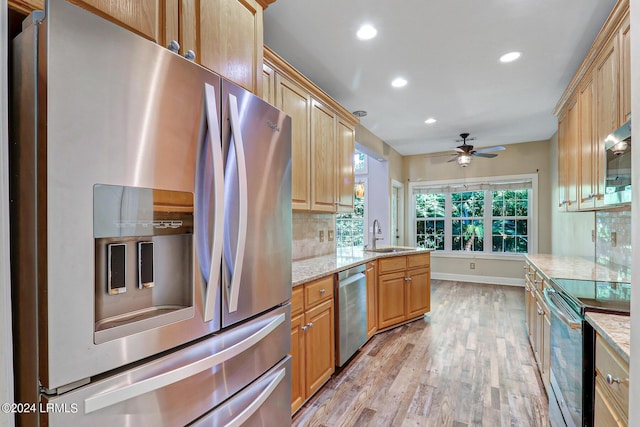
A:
[227,94,248,313]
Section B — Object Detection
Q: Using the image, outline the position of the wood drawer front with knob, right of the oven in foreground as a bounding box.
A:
[596,335,629,417]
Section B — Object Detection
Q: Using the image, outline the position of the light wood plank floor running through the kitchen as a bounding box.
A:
[293,280,549,427]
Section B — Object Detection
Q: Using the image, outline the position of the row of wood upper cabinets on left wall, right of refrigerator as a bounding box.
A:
[263,46,358,212]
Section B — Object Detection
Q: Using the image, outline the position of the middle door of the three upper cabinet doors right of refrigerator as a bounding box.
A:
[311,99,336,212]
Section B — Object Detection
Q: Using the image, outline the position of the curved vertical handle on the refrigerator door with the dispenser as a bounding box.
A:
[195,83,224,322]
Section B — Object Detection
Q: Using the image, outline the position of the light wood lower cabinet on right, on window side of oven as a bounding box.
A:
[525,263,551,389]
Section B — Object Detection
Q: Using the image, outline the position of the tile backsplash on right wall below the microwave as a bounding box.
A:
[596,207,631,277]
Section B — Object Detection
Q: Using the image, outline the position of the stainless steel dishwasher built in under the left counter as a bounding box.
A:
[335,264,367,366]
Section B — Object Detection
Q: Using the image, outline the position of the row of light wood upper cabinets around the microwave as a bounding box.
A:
[554,0,631,211]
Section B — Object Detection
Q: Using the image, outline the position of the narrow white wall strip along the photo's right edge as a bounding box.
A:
[629,0,640,426]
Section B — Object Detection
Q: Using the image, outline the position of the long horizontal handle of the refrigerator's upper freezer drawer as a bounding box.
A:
[84,313,286,414]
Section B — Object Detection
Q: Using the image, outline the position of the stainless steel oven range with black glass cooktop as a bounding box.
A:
[544,278,631,427]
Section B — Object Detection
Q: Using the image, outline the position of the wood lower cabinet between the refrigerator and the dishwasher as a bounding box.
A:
[290,275,335,414]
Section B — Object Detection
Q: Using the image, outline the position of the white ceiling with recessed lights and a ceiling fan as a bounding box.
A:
[264,0,615,155]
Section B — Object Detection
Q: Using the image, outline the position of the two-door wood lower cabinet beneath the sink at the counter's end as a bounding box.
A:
[378,252,431,329]
